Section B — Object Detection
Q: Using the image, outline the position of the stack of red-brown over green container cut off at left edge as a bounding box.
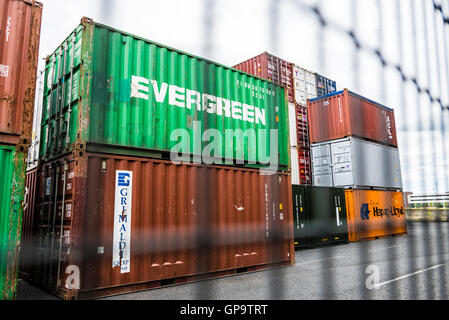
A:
[0,0,42,299]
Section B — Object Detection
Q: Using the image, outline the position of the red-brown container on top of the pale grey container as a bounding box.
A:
[309,89,398,147]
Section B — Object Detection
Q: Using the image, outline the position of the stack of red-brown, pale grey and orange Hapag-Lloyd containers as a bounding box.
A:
[309,89,407,241]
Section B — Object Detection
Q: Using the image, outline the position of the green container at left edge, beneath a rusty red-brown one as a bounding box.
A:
[0,146,26,300]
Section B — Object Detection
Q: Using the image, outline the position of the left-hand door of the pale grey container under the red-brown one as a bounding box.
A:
[312,144,333,187]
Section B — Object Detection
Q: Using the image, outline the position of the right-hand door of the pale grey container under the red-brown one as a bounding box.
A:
[331,140,354,187]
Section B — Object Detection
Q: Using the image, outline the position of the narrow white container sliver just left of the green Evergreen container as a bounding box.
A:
[27,71,45,171]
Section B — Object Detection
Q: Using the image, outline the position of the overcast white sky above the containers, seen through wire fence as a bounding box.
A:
[35,0,449,192]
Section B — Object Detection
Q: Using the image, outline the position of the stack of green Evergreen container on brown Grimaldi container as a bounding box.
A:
[21,18,294,297]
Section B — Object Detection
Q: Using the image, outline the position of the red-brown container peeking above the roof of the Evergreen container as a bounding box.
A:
[234,52,295,102]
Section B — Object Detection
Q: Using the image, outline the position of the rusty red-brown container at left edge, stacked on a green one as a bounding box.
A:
[0,0,42,145]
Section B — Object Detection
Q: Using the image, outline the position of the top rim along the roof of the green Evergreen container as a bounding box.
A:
[45,17,286,89]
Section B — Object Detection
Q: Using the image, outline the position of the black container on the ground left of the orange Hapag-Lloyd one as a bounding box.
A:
[293,185,348,248]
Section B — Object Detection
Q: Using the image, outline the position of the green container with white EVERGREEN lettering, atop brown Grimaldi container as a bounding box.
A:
[40,18,290,169]
